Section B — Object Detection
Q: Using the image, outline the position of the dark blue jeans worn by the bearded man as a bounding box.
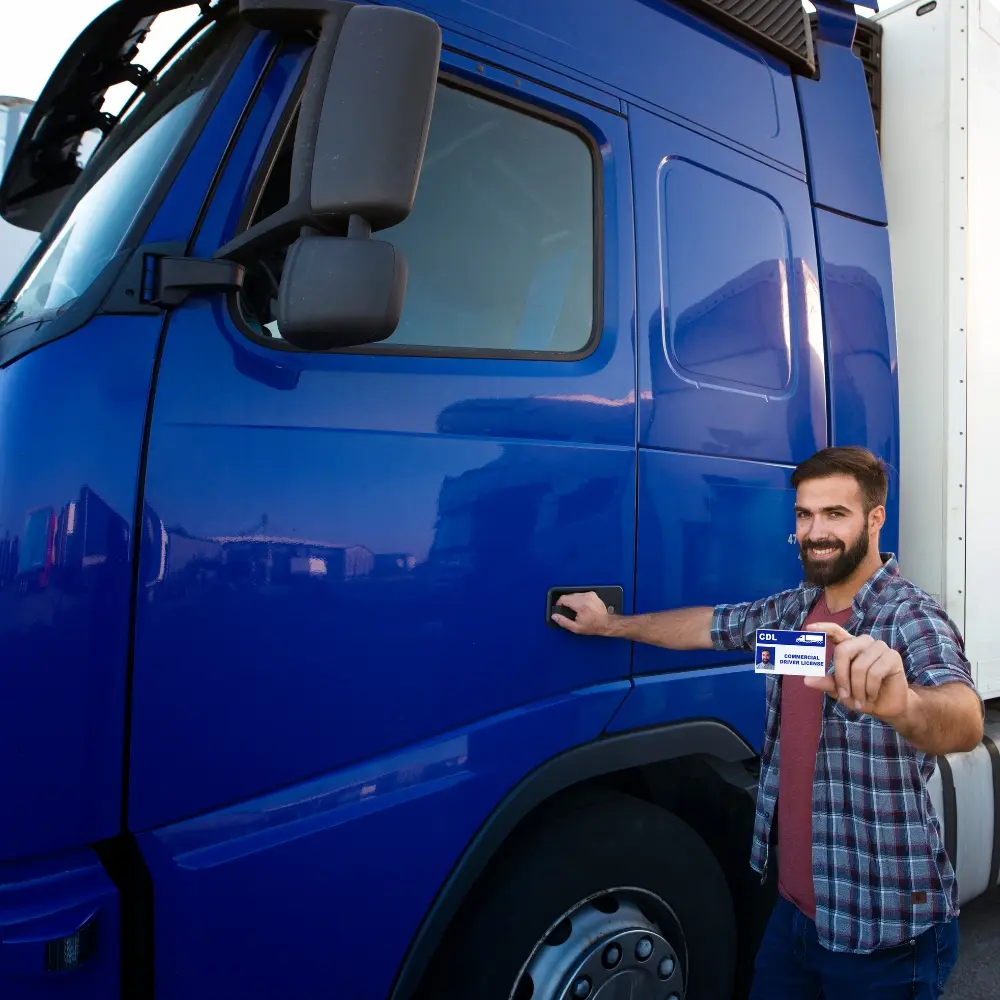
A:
[750,895,958,1000]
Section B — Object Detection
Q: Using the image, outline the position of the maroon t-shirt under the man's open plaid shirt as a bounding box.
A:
[778,594,852,920]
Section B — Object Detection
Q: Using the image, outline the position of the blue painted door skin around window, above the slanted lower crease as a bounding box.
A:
[129,58,636,829]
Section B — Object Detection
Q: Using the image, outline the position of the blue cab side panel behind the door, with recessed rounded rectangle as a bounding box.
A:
[615,99,827,746]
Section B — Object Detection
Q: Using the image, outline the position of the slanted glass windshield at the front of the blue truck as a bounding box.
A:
[0,8,239,336]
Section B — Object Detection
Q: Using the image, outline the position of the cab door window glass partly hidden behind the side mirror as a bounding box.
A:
[241,83,599,354]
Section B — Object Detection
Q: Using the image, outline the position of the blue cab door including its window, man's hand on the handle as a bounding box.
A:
[129,21,636,998]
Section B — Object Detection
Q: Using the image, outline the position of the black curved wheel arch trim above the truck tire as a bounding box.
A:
[390,719,756,1000]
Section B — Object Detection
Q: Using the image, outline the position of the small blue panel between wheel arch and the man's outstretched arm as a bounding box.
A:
[607,656,766,753]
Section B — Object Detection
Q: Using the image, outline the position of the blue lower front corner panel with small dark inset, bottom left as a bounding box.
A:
[0,850,121,1000]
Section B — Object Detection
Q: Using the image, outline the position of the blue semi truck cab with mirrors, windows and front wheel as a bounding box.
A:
[0,0,1000,1000]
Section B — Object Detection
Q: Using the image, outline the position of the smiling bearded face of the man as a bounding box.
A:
[795,476,882,587]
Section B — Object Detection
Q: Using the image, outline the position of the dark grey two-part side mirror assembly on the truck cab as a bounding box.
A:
[216,0,441,351]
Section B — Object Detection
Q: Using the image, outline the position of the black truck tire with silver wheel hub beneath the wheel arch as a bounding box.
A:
[423,792,736,1000]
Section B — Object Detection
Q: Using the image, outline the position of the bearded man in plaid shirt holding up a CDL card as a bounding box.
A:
[553,448,984,1000]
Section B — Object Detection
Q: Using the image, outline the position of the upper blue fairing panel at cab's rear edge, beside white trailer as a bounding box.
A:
[795,38,887,225]
